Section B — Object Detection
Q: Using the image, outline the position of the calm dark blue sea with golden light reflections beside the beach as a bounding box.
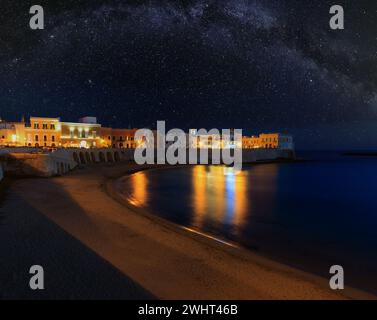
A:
[116,156,377,292]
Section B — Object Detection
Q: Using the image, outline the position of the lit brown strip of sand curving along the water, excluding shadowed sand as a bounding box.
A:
[0,163,376,300]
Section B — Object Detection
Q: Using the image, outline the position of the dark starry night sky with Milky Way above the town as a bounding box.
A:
[0,0,377,149]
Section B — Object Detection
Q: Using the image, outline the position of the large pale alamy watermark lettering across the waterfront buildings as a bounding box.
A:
[134,121,242,172]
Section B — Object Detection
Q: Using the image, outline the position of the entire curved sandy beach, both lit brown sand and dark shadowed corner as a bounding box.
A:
[0,163,374,299]
